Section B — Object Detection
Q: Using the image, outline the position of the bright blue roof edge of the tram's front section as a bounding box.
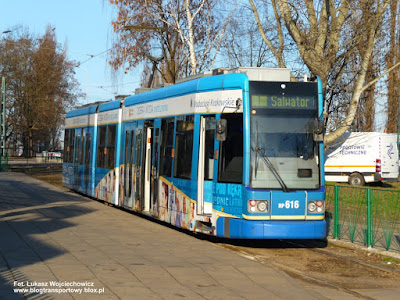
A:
[124,73,247,107]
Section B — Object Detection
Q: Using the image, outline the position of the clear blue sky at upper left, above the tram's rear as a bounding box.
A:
[0,0,141,104]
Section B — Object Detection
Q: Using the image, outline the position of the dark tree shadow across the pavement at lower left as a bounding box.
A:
[0,172,93,299]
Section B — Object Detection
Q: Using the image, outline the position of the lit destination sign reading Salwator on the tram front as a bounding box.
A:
[251,95,316,109]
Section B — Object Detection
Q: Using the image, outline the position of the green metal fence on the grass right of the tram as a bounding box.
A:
[326,185,400,252]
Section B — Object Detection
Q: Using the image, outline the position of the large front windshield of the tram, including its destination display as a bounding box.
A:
[250,82,320,191]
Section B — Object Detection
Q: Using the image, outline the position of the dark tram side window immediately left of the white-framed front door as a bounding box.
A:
[174,115,194,179]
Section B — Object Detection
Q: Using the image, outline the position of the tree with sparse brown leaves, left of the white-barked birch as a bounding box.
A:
[108,0,186,86]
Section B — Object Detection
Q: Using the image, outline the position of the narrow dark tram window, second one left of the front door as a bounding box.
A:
[160,118,175,177]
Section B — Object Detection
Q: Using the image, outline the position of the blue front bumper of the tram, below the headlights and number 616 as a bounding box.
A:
[217,217,327,239]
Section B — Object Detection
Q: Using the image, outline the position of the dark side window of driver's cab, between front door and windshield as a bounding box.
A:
[218,114,243,183]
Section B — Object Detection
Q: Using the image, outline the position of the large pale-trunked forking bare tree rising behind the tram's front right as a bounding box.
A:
[249,0,398,145]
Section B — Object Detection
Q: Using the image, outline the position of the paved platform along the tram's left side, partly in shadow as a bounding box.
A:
[0,172,396,300]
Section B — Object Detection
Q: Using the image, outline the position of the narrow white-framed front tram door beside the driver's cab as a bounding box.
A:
[197,115,215,215]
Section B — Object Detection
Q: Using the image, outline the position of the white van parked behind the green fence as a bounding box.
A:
[325,132,399,185]
